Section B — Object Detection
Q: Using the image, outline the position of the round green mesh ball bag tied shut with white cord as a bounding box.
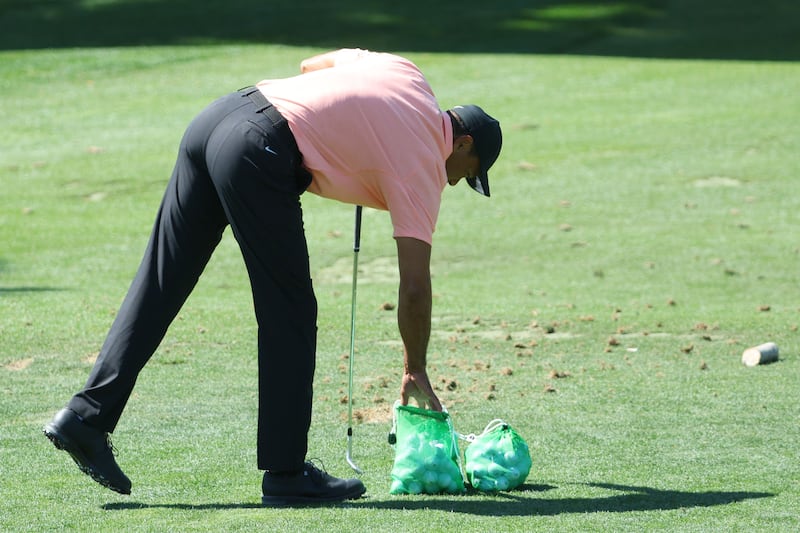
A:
[464,419,531,492]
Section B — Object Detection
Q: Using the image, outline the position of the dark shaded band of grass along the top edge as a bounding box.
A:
[0,0,800,60]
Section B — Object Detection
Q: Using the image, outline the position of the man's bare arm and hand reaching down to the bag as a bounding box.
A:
[396,237,442,411]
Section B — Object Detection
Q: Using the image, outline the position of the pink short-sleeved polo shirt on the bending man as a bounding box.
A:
[258,49,453,244]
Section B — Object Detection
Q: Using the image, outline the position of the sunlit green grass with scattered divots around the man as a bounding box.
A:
[0,3,800,531]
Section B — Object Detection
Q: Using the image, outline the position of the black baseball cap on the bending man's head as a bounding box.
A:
[450,105,503,196]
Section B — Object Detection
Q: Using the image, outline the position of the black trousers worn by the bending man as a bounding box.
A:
[69,88,317,470]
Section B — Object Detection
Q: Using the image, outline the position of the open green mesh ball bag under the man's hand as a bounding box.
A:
[389,402,464,494]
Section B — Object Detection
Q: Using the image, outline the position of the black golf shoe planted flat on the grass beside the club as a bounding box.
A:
[261,462,367,506]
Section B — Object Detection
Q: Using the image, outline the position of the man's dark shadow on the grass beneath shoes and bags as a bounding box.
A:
[102,483,775,516]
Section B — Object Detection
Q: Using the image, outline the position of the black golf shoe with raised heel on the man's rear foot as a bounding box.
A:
[44,409,131,494]
